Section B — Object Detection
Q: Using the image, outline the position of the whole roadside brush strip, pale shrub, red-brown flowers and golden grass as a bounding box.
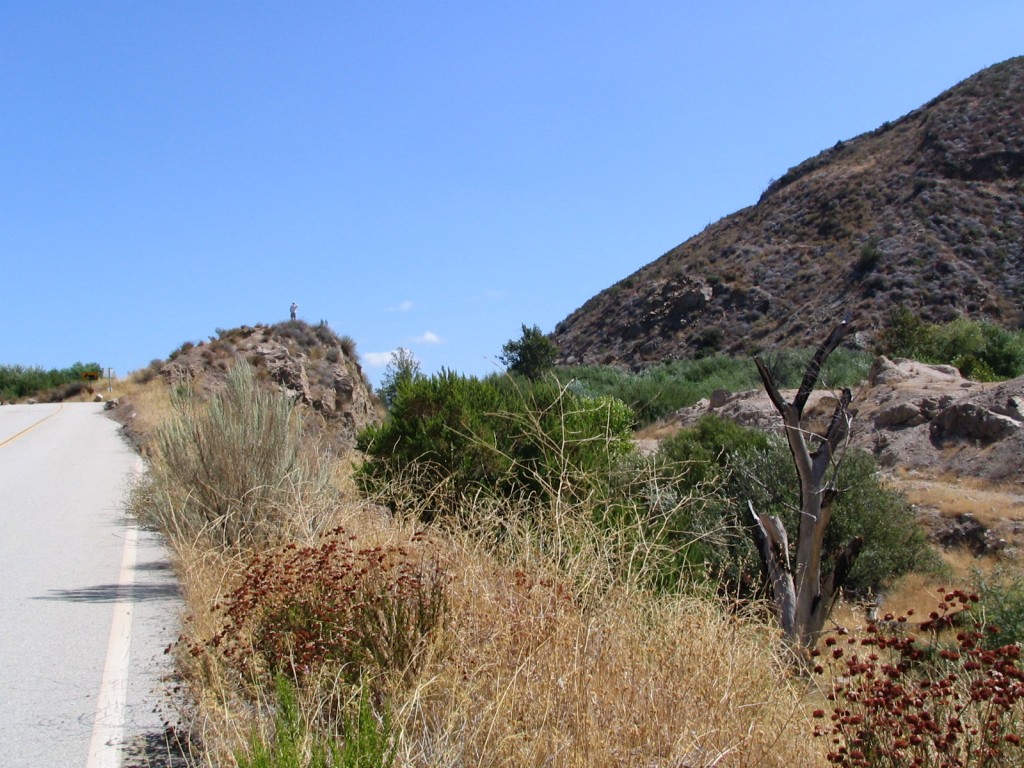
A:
[135,362,823,767]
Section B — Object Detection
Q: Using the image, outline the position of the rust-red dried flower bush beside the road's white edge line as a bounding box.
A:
[193,527,447,683]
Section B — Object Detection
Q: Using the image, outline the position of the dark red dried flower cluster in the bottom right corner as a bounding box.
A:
[814,590,1024,768]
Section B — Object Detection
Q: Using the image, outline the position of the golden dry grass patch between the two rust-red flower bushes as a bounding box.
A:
[398,532,814,766]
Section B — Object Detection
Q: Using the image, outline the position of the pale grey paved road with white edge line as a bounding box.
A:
[0,403,178,768]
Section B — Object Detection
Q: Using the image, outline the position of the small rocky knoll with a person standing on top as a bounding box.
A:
[150,321,381,447]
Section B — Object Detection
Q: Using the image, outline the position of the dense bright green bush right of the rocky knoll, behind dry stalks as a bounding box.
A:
[357,371,634,519]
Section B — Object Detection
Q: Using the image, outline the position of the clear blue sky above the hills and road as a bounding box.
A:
[0,0,1024,381]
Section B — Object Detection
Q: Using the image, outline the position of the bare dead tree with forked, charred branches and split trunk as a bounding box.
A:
[748,321,863,659]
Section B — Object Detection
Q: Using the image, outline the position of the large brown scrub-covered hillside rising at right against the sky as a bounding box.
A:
[552,57,1024,368]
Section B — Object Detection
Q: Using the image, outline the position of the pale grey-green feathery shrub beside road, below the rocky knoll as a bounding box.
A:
[132,360,331,546]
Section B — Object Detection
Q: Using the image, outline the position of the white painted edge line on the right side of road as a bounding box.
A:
[85,522,138,768]
